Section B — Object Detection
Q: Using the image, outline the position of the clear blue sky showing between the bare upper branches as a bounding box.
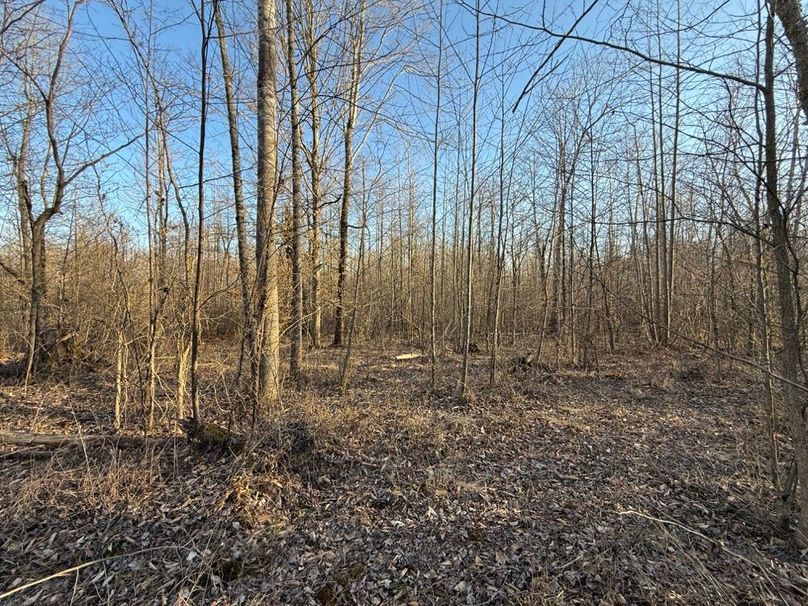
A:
[0,0,784,253]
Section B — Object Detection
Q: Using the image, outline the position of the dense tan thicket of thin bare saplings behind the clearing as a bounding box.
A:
[0,218,759,404]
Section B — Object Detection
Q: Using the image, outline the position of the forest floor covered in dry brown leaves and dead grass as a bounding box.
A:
[0,349,808,606]
